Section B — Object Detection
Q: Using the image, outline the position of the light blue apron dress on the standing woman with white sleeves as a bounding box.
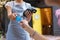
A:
[7,1,30,40]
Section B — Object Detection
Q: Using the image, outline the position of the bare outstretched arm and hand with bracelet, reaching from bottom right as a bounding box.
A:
[21,20,48,40]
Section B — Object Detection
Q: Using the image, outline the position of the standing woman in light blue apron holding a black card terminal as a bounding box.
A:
[5,0,32,40]
